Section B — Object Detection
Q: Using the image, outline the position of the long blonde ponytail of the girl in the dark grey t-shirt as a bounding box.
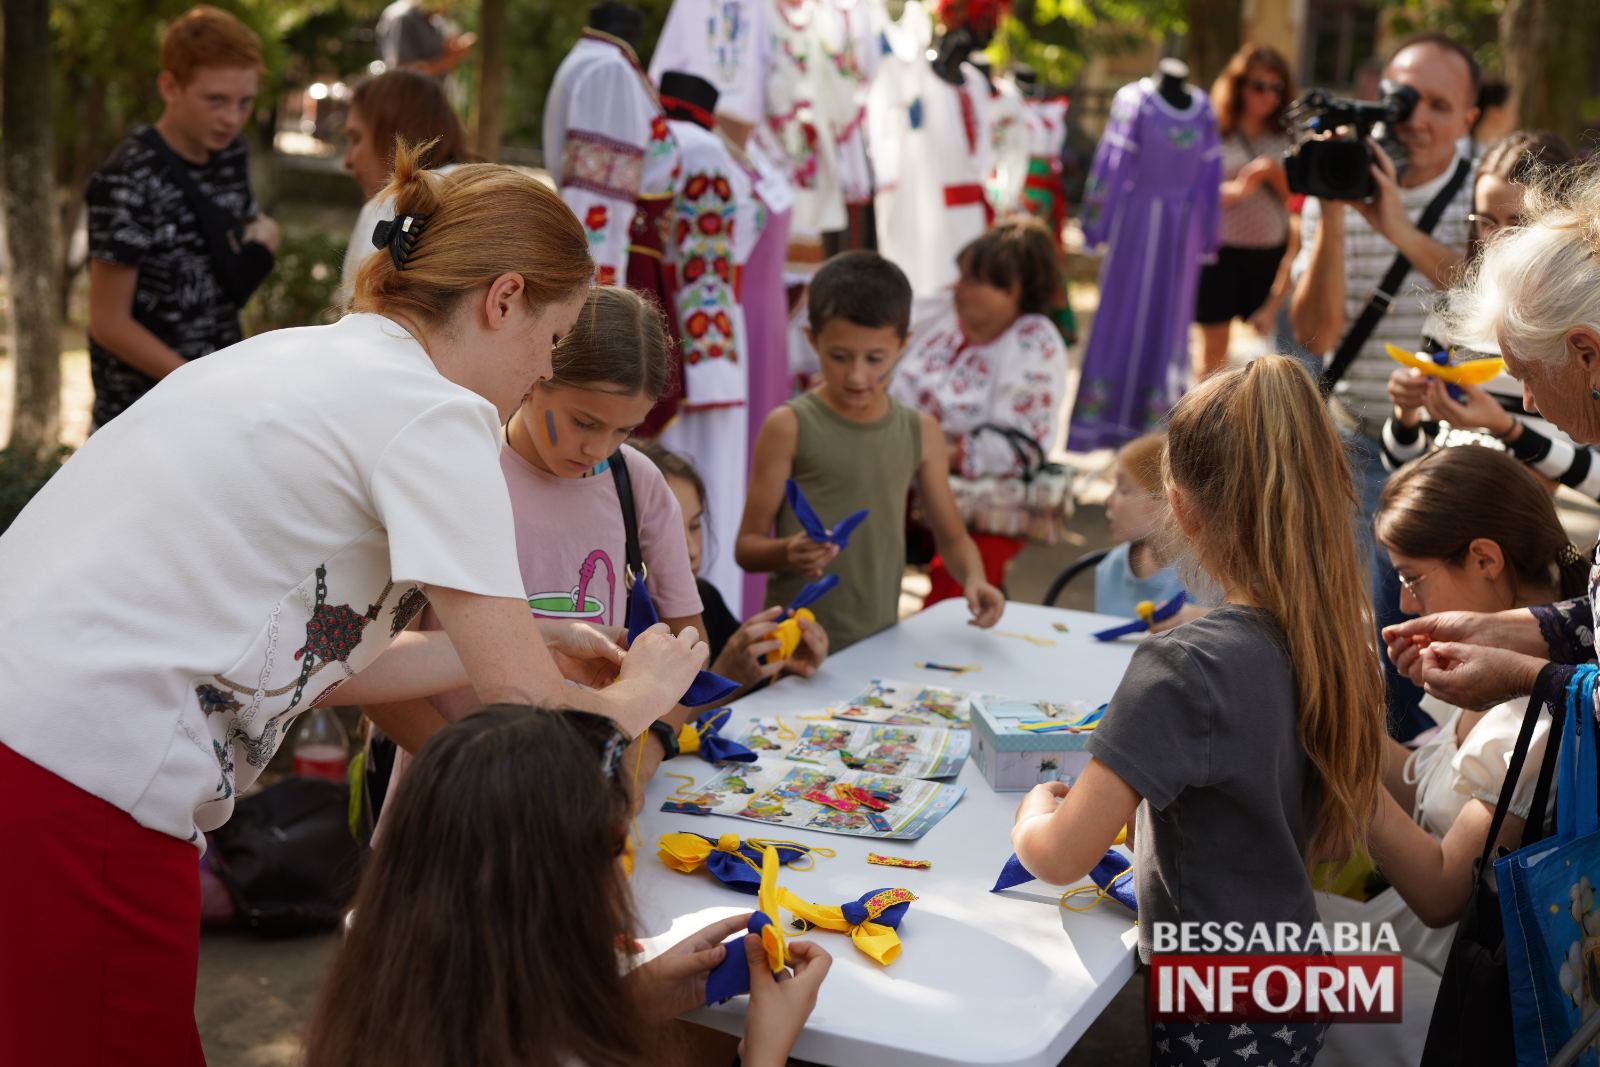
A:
[1165,355,1386,859]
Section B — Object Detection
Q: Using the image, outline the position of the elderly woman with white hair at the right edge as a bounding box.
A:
[1384,168,1600,707]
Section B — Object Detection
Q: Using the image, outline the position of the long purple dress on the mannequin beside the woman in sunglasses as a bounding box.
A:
[1067,78,1222,451]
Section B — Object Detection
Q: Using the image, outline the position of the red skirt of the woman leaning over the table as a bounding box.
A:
[0,744,205,1067]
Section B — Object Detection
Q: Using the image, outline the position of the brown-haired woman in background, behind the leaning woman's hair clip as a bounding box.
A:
[334,69,478,304]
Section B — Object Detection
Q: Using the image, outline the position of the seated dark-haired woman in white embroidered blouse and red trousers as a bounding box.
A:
[890,218,1067,605]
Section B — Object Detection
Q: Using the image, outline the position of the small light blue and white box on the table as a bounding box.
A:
[971,696,1093,793]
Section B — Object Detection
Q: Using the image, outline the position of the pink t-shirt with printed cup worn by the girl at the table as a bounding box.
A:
[422,445,701,720]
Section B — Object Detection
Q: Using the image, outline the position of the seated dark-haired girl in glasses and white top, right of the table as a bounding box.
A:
[1320,448,1587,971]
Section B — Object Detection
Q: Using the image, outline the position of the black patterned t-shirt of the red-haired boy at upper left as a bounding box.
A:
[85,133,259,426]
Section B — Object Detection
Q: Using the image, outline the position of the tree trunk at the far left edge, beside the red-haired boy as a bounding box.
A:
[0,0,61,453]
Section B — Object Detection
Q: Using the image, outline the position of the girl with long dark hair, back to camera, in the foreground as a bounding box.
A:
[306,705,830,1067]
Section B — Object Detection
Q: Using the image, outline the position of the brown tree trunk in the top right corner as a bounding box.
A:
[1499,0,1600,144]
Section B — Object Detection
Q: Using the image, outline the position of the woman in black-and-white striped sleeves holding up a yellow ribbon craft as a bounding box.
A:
[1382,130,1600,499]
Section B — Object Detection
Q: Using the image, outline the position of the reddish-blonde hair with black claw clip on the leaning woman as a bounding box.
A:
[350,138,595,326]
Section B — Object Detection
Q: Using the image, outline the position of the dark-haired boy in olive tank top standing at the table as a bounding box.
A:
[734,251,1005,651]
